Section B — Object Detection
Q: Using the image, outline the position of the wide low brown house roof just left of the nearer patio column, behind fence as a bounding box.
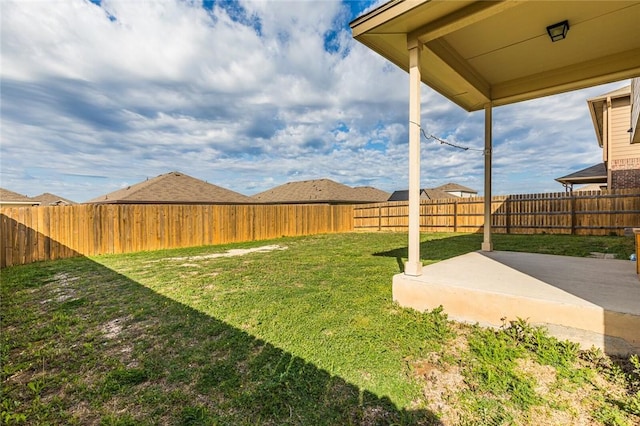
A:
[251,179,389,204]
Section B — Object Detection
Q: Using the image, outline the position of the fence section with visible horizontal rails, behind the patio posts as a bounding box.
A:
[354,188,640,235]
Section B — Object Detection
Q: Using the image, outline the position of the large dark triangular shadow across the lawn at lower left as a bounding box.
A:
[1,258,441,425]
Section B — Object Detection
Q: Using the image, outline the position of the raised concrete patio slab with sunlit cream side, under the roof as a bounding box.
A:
[393,251,640,355]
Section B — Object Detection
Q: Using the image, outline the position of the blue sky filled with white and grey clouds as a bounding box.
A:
[0,0,628,202]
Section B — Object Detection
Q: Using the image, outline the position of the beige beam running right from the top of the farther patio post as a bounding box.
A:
[491,49,640,106]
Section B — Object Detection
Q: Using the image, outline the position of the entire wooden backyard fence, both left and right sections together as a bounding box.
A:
[0,189,640,267]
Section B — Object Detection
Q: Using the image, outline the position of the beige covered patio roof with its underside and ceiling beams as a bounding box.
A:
[350,0,640,111]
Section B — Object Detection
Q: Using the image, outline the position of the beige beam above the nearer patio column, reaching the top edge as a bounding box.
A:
[407,0,522,43]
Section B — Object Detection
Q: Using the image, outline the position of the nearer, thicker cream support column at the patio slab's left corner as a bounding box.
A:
[404,44,422,276]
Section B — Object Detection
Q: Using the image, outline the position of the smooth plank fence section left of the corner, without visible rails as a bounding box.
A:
[0,204,353,267]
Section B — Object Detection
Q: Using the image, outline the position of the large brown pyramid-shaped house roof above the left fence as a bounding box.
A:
[87,172,255,204]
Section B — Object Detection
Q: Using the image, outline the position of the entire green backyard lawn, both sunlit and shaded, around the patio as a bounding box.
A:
[0,233,640,425]
